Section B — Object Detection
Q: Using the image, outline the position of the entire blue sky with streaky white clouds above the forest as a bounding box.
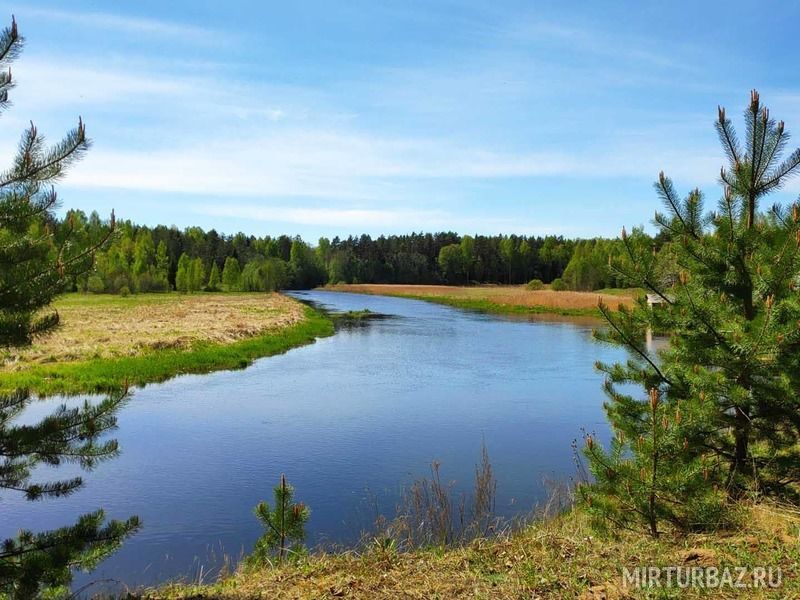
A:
[0,0,800,240]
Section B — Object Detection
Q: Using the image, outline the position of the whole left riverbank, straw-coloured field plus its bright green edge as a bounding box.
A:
[0,293,333,396]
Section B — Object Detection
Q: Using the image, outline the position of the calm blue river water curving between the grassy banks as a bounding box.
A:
[7,291,624,585]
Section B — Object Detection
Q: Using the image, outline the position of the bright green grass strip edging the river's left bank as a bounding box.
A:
[0,308,333,396]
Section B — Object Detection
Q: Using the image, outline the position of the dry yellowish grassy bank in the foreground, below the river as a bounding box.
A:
[152,504,800,600]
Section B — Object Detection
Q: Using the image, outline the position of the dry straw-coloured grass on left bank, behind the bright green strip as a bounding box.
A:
[0,294,303,373]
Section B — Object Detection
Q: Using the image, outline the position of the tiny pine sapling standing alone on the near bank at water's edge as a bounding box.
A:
[247,475,311,566]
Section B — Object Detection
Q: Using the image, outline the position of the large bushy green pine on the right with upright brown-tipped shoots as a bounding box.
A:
[582,91,800,528]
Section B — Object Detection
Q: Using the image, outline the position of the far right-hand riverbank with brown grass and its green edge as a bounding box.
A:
[324,284,638,317]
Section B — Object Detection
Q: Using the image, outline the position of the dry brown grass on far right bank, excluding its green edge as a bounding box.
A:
[327,284,634,310]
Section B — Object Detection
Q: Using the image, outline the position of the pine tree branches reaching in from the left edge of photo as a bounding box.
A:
[0,20,138,598]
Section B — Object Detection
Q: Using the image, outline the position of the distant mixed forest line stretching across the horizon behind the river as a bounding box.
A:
[51,211,660,294]
